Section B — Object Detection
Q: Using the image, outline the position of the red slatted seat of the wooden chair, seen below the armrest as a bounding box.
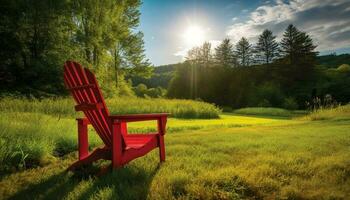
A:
[123,134,157,150]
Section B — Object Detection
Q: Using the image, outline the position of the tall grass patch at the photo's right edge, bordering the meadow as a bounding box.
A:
[301,104,350,121]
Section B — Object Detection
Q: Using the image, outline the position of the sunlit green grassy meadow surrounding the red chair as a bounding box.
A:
[0,99,350,199]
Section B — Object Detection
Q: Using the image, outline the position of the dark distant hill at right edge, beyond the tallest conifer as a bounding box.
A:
[316,54,350,68]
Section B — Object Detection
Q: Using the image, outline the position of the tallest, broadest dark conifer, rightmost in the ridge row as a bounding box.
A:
[280,24,317,65]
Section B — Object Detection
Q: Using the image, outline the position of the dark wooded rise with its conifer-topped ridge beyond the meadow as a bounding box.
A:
[167,24,350,109]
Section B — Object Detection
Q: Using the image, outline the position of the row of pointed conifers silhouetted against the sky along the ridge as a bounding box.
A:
[186,24,317,67]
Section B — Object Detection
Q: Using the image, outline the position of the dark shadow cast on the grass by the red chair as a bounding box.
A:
[9,165,160,200]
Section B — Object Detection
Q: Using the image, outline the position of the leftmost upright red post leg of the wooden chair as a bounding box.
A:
[77,118,89,160]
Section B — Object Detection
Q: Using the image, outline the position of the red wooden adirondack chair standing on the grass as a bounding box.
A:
[64,61,168,170]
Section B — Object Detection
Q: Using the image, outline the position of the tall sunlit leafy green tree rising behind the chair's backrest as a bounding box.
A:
[73,0,150,85]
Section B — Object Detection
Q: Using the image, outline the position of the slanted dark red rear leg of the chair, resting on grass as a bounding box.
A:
[67,148,110,171]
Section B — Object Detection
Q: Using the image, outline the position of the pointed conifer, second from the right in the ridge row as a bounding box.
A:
[256,29,278,64]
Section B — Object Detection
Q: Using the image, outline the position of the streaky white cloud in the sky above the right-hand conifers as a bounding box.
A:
[227,0,350,51]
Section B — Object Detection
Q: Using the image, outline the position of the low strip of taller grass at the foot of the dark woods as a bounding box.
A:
[233,107,307,117]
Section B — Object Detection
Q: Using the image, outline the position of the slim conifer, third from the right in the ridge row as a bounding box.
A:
[235,37,253,66]
